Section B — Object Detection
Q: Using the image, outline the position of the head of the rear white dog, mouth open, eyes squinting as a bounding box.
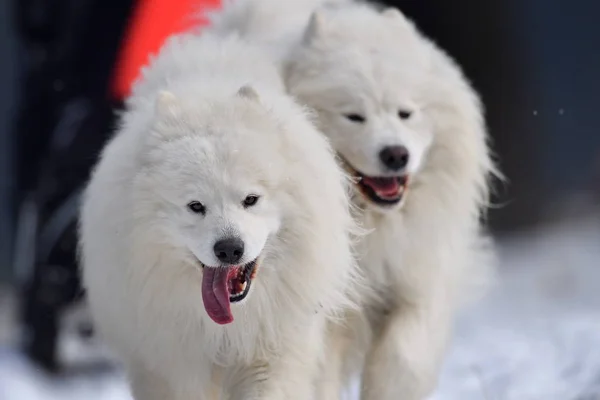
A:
[285,5,433,210]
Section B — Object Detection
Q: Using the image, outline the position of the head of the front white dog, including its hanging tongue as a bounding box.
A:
[138,87,282,324]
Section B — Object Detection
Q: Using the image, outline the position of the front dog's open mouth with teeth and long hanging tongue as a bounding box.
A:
[200,259,258,325]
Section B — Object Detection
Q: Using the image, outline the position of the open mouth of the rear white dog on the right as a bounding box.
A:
[344,160,408,207]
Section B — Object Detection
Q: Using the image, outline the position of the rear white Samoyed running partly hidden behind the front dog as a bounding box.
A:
[209,0,496,400]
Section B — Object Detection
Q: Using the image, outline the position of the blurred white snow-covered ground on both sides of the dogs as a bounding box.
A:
[0,218,600,400]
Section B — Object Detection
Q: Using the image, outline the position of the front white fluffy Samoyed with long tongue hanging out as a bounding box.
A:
[80,35,355,400]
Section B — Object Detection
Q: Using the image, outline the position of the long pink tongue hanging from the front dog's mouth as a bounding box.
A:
[202,267,233,325]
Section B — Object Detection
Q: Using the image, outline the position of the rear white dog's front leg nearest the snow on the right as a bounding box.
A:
[362,301,452,400]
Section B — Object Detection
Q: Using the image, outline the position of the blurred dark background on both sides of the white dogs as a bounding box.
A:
[0,0,600,386]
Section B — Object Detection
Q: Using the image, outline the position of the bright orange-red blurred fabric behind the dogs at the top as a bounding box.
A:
[111,0,221,99]
